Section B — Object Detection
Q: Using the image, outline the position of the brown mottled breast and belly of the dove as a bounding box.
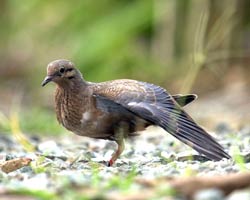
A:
[55,86,149,140]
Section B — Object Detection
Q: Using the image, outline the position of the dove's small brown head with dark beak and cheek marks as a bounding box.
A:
[42,59,81,86]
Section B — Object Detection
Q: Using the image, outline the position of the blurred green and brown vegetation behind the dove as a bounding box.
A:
[0,0,250,134]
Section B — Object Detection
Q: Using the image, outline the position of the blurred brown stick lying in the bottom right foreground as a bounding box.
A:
[137,173,250,199]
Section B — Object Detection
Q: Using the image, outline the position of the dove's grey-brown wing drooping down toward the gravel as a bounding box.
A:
[93,79,230,160]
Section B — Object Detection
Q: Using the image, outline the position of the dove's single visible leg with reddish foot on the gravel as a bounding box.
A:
[108,123,127,167]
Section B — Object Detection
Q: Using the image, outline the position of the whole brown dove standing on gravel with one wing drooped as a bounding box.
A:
[42,59,230,166]
